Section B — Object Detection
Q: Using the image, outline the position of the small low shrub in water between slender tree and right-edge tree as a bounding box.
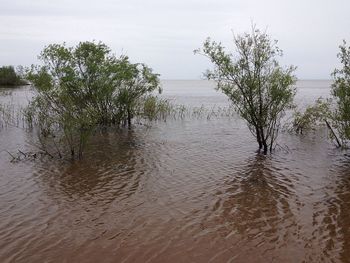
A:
[292,98,333,134]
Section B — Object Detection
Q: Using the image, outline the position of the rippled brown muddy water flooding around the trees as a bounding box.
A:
[0,81,350,262]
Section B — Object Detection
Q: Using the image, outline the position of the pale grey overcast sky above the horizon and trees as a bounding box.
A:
[0,0,350,79]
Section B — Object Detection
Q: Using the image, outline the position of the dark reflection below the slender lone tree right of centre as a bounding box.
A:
[215,155,293,243]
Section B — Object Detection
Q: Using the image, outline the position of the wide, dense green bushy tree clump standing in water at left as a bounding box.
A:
[25,42,159,158]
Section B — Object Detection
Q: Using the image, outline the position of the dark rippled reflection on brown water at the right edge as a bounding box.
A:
[313,159,350,262]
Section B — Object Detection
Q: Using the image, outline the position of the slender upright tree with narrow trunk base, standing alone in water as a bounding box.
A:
[195,27,296,154]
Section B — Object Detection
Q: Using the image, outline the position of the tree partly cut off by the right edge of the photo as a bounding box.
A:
[332,40,350,141]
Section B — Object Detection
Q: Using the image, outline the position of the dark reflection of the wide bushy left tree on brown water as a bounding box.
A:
[37,130,145,202]
